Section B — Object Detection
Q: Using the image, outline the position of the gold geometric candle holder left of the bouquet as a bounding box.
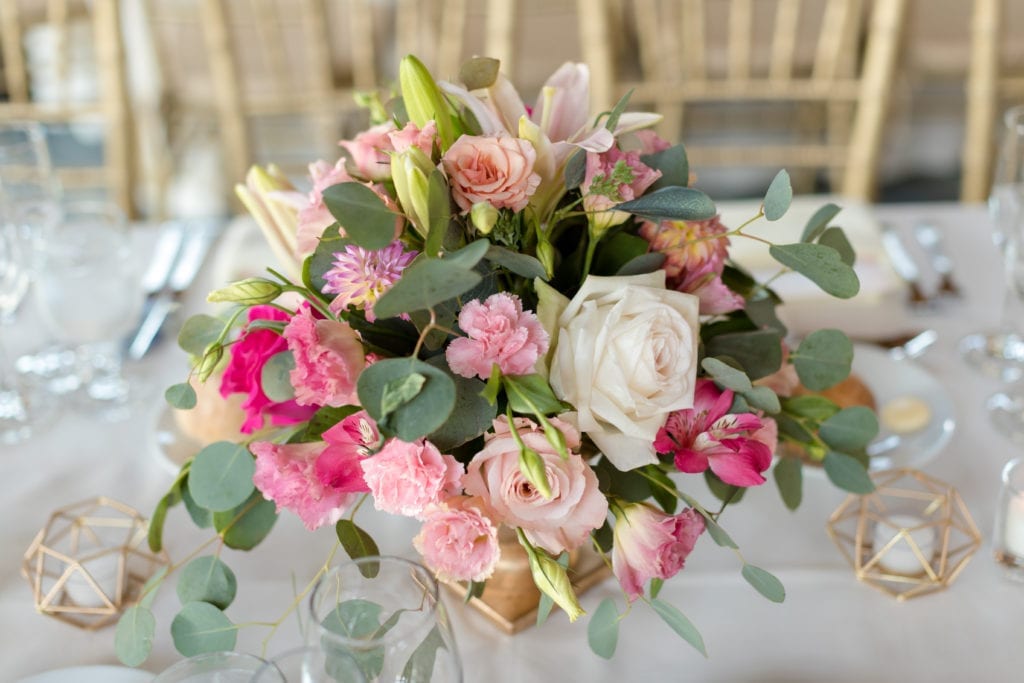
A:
[22,497,170,630]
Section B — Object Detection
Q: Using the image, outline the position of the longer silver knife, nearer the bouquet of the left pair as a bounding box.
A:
[128,221,220,360]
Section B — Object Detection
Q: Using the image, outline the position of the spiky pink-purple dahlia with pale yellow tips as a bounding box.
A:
[324,240,417,323]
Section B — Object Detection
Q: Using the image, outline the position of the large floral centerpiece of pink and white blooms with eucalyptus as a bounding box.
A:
[118,56,878,663]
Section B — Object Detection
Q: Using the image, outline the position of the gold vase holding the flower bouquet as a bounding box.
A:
[445,525,611,634]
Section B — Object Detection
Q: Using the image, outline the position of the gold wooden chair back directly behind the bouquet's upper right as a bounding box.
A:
[578,0,907,199]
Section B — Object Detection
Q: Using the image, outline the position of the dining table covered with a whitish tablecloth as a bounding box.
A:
[0,203,1024,683]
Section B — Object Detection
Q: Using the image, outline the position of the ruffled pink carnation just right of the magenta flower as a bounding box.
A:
[284,304,366,408]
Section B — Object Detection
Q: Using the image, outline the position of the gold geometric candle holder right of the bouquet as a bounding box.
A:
[826,469,981,601]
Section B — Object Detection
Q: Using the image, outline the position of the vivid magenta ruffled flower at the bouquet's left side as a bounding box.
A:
[220,306,315,434]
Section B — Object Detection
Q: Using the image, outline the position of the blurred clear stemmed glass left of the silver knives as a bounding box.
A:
[35,202,142,419]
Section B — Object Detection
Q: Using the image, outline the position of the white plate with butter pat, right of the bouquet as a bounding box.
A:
[853,344,956,472]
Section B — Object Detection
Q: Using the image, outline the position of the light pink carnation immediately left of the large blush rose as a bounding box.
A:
[361,438,463,518]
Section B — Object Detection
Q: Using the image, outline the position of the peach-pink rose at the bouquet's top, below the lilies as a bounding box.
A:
[441,135,541,211]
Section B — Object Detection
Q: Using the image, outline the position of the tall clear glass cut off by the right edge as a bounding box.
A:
[959,105,1024,382]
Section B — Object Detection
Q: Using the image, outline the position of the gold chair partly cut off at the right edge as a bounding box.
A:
[961,0,1024,202]
